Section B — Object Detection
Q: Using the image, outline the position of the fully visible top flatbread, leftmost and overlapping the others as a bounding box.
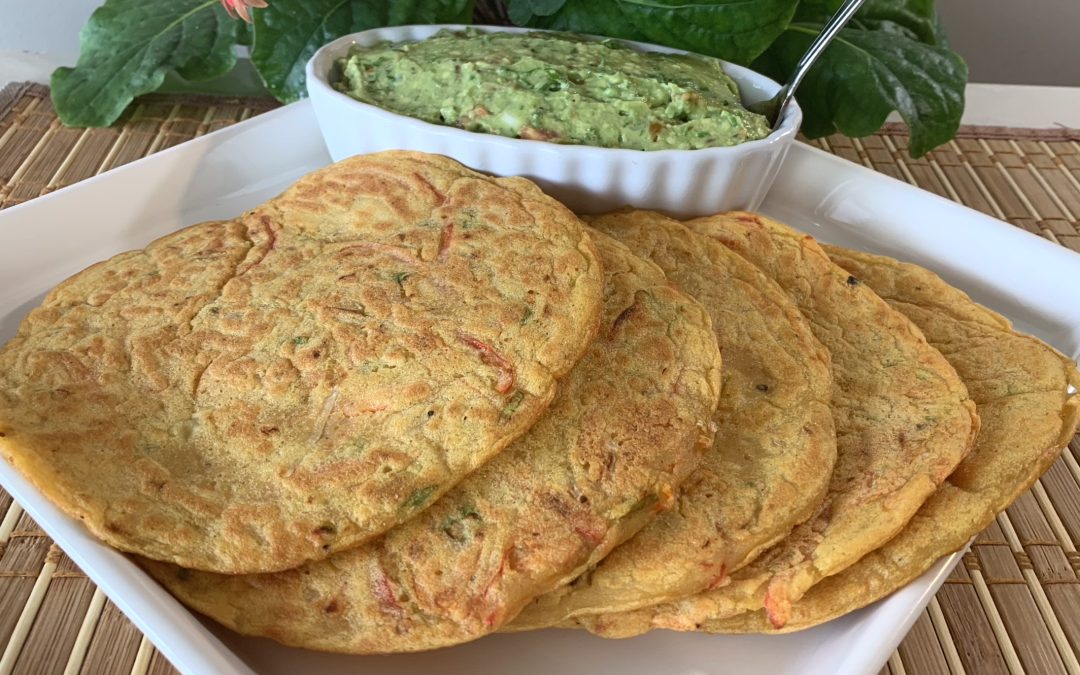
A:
[0,152,603,572]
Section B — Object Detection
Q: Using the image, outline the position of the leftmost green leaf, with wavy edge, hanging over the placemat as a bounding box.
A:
[52,0,238,126]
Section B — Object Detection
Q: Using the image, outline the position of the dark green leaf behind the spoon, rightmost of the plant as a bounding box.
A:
[754,10,968,157]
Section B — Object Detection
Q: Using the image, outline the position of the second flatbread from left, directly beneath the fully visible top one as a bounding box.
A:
[139,227,720,653]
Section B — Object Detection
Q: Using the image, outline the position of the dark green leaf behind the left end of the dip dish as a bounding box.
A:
[252,0,473,103]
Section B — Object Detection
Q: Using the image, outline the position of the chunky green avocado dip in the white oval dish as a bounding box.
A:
[330,29,769,150]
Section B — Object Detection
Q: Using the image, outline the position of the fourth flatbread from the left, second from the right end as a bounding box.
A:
[574,212,978,637]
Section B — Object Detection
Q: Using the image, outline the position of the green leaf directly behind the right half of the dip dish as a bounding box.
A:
[514,0,798,64]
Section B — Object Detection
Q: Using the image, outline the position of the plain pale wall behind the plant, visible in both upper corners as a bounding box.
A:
[0,0,1080,86]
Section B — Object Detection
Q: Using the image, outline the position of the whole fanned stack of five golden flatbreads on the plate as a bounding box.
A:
[0,151,1080,653]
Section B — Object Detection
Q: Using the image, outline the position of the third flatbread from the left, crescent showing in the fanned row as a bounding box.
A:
[511,211,836,630]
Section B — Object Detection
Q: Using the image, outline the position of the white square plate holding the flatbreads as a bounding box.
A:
[0,103,1080,675]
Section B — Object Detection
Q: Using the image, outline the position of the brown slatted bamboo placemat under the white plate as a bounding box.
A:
[0,84,1080,675]
